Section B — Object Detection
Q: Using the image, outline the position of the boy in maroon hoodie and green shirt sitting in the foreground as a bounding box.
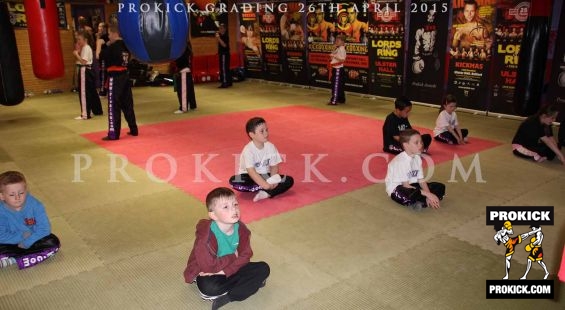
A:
[184,187,270,310]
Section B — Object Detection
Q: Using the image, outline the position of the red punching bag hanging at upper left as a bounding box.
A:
[24,0,65,80]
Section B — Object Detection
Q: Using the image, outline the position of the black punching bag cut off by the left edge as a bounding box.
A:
[0,2,24,105]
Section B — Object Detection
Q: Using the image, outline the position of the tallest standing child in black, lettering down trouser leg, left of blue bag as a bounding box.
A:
[102,25,139,140]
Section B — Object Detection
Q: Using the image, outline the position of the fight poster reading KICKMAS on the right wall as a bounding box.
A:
[447,0,496,110]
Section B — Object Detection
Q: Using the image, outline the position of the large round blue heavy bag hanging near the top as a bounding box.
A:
[118,0,188,63]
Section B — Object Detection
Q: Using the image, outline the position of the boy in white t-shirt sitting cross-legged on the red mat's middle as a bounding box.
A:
[229,117,294,202]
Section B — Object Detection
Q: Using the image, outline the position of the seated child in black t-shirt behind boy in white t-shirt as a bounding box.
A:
[383,97,432,155]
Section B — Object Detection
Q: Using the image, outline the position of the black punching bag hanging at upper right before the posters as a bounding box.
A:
[514,0,551,116]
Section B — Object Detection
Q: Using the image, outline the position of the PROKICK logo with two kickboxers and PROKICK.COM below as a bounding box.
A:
[486,206,554,299]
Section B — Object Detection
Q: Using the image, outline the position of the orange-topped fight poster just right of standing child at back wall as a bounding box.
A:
[238,3,263,79]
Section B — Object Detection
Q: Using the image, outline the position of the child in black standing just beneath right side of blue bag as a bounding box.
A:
[173,41,196,114]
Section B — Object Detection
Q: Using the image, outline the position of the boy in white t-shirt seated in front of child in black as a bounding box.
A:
[385,129,445,211]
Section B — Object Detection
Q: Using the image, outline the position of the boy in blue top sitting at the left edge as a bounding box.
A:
[0,171,60,269]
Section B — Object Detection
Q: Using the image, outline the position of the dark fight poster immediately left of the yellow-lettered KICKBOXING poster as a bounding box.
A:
[279,2,308,85]
